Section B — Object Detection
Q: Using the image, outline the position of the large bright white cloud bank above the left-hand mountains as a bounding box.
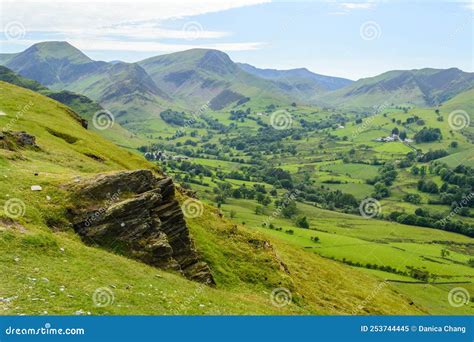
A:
[0,0,270,51]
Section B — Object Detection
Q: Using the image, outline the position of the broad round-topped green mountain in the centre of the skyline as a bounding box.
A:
[138,49,288,109]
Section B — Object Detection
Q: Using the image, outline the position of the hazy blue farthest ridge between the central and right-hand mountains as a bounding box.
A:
[237,63,353,97]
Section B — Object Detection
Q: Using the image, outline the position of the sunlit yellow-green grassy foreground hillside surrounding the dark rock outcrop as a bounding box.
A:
[0,82,426,314]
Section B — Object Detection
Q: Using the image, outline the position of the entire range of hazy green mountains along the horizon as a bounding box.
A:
[0,42,474,120]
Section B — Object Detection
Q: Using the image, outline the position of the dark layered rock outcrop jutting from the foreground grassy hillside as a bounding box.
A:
[69,170,214,285]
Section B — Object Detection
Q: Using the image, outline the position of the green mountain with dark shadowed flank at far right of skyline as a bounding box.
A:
[317,68,474,109]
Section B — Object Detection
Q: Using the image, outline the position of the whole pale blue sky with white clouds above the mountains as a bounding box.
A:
[0,0,474,80]
